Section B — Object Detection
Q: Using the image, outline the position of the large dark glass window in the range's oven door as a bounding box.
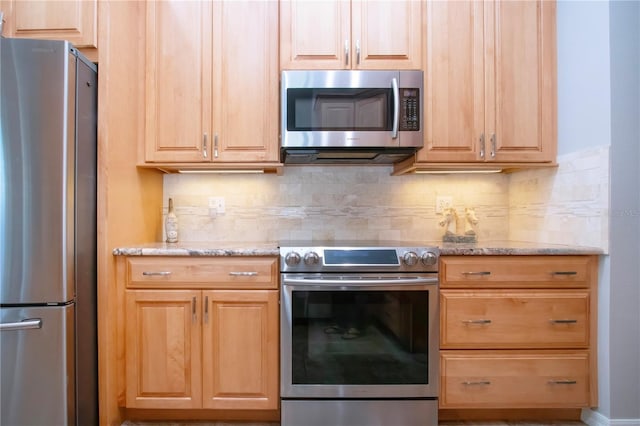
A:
[291,290,429,385]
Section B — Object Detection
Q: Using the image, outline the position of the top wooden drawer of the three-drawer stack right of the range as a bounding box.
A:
[440,256,597,288]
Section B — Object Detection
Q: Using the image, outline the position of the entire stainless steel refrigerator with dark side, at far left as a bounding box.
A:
[0,38,98,426]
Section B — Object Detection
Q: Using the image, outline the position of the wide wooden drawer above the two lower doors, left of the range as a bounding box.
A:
[126,256,278,289]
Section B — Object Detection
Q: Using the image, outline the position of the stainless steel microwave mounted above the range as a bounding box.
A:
[280,70,424,164]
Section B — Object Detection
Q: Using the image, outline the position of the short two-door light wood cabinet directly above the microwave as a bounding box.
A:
[280,0,426,70]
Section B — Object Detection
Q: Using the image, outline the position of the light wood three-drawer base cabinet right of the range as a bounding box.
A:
[439,255,598,410]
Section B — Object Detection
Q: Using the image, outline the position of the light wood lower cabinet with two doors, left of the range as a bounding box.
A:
[123,258,279,410]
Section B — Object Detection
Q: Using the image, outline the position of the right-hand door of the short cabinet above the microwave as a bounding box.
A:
[351,0,425,70]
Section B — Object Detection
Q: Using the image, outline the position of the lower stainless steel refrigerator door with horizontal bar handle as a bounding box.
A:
[0,304,75,426]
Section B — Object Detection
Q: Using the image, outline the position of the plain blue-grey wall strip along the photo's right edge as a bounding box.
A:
[608,1,640,426]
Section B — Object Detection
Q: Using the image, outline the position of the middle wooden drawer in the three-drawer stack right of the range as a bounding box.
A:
[440,290,590,349]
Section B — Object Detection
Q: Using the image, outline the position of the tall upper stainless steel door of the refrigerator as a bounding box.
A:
[0,39,76,304]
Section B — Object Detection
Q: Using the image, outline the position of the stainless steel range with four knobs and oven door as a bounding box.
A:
[280,242,439,426]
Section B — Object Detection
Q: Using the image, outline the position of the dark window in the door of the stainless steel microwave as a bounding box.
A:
[287,88,393,131]
